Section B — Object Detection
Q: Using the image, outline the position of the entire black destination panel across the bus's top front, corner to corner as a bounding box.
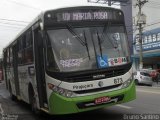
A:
[45,9,124,23]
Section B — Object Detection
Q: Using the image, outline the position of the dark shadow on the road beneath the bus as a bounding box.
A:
[4,101,123,120]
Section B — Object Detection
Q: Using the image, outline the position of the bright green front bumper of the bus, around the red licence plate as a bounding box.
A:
[49,81,136,114]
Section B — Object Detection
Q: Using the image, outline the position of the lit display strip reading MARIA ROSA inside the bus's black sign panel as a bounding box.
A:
[57,11,123,22]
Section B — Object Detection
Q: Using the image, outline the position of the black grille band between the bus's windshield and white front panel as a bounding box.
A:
[46,63,132,83]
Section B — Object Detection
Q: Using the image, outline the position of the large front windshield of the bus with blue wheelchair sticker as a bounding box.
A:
[46,25,130,72]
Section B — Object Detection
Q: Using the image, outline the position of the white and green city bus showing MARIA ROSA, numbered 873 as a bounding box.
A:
[3,6,136,115]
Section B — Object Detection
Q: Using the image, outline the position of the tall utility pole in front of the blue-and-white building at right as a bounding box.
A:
[136,0,148,69]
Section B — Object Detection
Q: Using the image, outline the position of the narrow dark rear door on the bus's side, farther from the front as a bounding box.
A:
[12,43,20,96]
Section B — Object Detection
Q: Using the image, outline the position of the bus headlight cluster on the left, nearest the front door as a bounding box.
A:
[48,83,75,97]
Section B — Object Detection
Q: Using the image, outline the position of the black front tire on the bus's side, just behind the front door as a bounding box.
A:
[29,85,39,114]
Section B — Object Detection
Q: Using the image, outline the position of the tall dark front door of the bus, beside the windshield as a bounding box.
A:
[34,28,48,108]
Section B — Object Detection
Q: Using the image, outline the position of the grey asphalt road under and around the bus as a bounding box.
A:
[0,80,160,120]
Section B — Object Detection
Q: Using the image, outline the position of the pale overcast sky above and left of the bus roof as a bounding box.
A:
[0,0,120,57]
